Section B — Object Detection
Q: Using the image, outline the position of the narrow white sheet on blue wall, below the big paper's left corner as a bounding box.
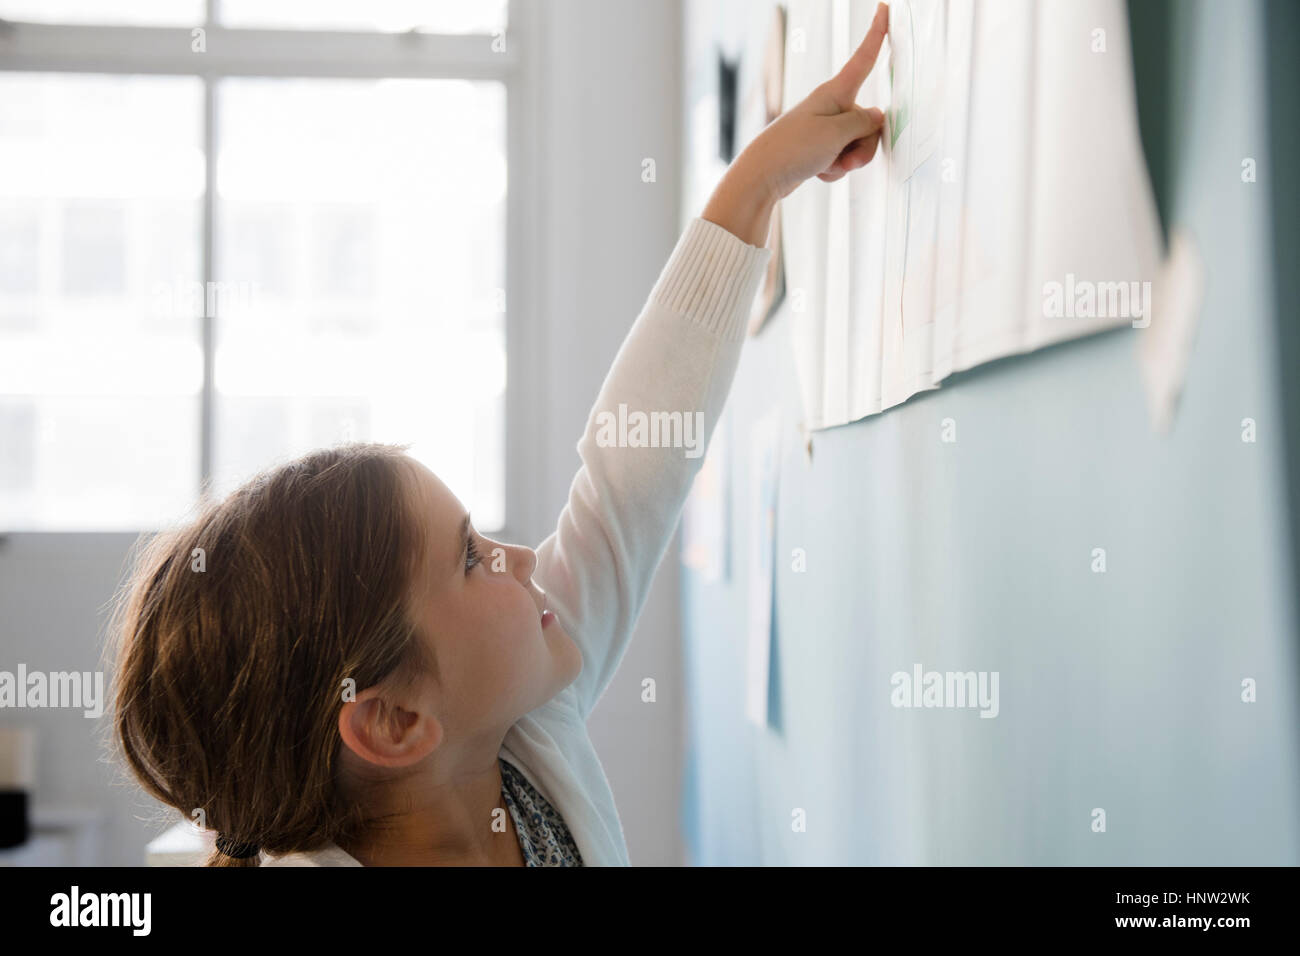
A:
[745,410,781,727]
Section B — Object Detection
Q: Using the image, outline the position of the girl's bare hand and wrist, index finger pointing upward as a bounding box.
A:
[702,4,889,246]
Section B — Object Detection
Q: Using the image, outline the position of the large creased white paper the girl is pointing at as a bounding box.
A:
[783,0,1160,429]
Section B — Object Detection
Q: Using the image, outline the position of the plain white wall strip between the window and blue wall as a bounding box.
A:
[540,0,684,865]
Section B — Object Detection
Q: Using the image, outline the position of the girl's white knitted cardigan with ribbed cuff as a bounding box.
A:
[261,217,772,866]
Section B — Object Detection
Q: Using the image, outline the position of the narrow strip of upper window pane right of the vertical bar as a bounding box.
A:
[220,0,506,34]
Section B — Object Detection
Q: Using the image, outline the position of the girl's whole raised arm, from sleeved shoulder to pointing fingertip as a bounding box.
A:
[534,5,887,718]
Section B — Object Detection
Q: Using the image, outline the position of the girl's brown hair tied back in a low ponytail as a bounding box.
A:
[112,444,437,866]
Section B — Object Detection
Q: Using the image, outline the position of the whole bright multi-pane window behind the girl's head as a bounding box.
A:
[0,0,521,532]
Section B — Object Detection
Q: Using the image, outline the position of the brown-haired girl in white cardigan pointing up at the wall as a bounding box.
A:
[113,4,888,866]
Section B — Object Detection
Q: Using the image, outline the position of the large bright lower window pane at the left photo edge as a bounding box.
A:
[0,73,203,531]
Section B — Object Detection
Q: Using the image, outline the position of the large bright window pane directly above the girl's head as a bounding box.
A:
[215,79,506,531]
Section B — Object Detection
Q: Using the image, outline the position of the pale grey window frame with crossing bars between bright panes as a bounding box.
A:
[0,0,546,541]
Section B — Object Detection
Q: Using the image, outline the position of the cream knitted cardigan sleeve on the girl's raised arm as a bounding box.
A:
[534,217,772,719]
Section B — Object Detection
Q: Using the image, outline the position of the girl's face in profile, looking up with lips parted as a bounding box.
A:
[395,459,582,739]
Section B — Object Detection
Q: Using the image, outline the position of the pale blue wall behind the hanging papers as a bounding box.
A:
[683,3,1300,865]
